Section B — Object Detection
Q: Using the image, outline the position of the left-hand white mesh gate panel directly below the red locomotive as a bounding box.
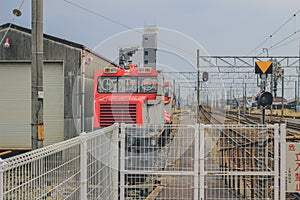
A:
[120,124,199,200]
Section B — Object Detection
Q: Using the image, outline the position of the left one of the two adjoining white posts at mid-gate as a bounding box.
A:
[194,124,200,200]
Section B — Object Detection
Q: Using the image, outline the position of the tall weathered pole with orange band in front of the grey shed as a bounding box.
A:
[31,0,44,149]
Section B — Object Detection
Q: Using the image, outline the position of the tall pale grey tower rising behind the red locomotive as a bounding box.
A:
[142,26,158,69]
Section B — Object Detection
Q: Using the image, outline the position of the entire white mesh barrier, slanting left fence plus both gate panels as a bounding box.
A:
[0,124,286,200]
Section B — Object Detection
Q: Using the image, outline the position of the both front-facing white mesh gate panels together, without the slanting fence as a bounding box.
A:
[120,122,285,200]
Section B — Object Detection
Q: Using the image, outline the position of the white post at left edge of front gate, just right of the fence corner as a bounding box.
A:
[120,123,126,200]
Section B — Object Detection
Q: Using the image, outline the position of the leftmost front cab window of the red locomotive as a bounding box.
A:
[98,77,118,93]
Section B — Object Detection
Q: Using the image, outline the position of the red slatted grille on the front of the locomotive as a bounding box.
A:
[99,104,136,127]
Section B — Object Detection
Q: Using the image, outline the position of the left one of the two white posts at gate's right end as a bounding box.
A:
[274,124,280,199]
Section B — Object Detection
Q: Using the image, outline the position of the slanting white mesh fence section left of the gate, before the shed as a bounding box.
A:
[0,125,119,200]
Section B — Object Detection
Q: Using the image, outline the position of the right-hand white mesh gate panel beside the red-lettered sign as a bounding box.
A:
[199,125,286,200]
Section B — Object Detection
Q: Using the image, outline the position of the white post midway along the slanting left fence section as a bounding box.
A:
[80,132,87,200]
